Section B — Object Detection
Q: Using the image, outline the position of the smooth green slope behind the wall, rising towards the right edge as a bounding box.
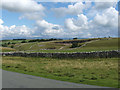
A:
[25,39,118,53]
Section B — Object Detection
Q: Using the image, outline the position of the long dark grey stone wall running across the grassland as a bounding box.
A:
[0,50,120,58]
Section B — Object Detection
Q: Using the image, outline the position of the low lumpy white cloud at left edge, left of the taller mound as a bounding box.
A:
[0,19,32,39]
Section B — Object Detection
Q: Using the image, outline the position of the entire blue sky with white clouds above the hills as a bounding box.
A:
[0,0,119,39]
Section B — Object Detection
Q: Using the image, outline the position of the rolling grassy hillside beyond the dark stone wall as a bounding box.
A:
[2,38,118,53]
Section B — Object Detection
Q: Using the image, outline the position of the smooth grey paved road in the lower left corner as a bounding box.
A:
[2,70,109,88]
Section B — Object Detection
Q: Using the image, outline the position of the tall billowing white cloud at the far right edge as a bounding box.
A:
[89,7,118,37]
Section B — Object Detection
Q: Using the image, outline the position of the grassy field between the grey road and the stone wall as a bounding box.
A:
[2,56,118,88]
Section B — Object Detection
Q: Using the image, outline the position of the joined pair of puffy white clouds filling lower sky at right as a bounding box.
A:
[65,7,118,37]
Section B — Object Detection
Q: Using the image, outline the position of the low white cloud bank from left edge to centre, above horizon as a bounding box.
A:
[0,19,64,39]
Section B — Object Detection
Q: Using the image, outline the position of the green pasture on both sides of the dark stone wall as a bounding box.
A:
[0,38,120,88]
